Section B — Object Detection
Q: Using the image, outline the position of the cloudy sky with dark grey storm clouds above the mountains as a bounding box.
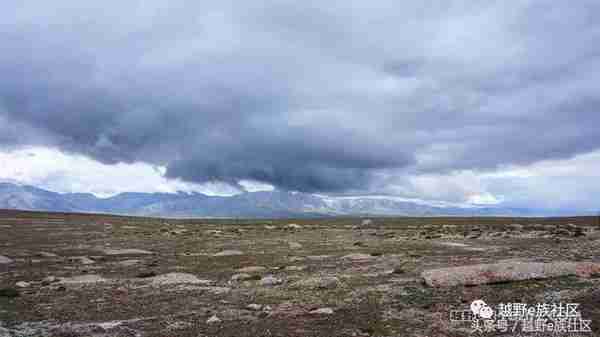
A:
[0,0,600,210]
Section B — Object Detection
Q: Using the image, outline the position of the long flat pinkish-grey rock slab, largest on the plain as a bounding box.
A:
[421,262,600,287]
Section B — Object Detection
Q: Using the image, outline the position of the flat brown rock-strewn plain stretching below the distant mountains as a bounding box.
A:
[0,212,600,337]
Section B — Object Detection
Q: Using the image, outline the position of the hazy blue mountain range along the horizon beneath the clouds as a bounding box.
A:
[0,183,568,218]
